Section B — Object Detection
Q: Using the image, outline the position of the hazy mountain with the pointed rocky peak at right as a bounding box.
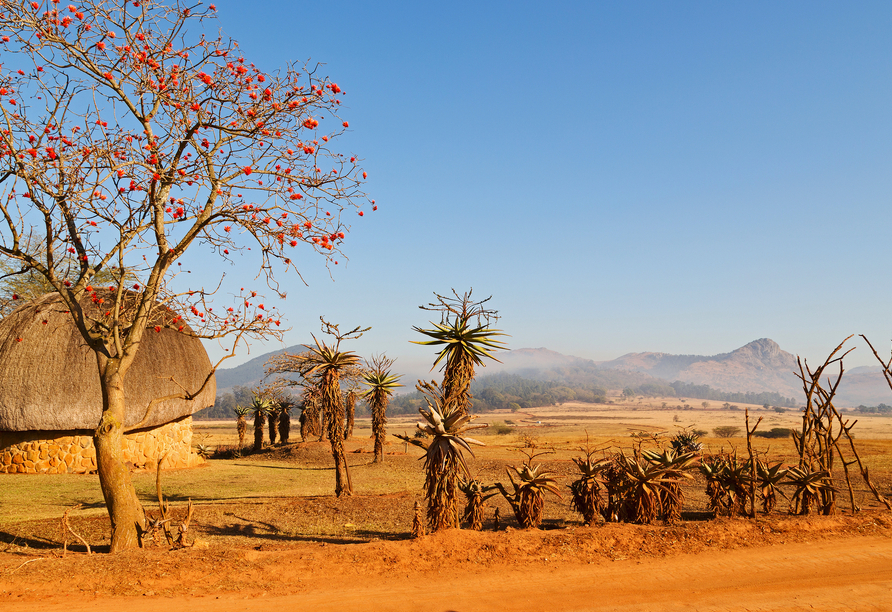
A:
[600,338,802,397]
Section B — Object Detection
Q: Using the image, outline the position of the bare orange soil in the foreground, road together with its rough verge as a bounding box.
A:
[0,512,892,612]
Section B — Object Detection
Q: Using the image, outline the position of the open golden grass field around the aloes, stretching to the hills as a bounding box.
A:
[0,400,892,543]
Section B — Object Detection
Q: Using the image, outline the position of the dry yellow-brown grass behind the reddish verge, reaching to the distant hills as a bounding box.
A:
[0,404,892,549]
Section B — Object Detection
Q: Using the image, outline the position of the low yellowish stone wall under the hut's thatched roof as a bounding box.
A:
[0,416,204,474]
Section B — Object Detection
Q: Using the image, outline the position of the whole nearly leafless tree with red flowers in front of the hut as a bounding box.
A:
[0,0,373,551]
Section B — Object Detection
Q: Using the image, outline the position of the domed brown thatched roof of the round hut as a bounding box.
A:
[0,293,217,431]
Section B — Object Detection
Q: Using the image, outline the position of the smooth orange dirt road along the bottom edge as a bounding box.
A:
[8,536,892,612]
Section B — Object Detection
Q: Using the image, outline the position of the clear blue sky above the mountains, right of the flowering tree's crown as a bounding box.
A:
[200,0,892,370]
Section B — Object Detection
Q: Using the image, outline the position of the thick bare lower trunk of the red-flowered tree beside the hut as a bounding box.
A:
[93,368,146,552]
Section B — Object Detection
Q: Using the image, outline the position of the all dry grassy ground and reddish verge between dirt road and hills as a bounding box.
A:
[0,405,892,598]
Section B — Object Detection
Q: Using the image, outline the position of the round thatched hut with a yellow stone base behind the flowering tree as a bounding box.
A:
[0,293,216,474]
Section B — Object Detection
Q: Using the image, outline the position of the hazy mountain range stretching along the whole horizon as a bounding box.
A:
[211,338,892,406]
